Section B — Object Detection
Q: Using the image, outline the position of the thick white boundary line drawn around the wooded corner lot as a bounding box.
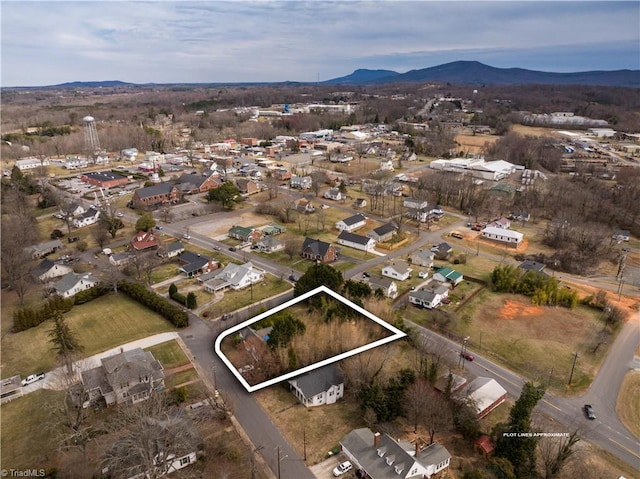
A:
[214,286,406,393]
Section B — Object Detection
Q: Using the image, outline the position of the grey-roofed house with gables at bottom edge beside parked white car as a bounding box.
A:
[340,428,451,479]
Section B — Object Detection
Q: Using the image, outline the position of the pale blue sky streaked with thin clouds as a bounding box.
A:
[0,0,640,87]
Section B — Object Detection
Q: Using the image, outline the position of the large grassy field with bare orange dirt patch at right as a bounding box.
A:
[405,291,606,394]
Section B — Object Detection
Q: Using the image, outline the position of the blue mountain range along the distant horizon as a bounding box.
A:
[42,61,640,88]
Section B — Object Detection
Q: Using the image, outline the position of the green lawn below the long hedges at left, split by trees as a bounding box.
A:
[1,294,175,378]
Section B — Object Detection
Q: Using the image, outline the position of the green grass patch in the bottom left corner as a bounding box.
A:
[0,389,64,470]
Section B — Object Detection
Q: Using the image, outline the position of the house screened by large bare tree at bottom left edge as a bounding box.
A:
[101,408,204,479]
